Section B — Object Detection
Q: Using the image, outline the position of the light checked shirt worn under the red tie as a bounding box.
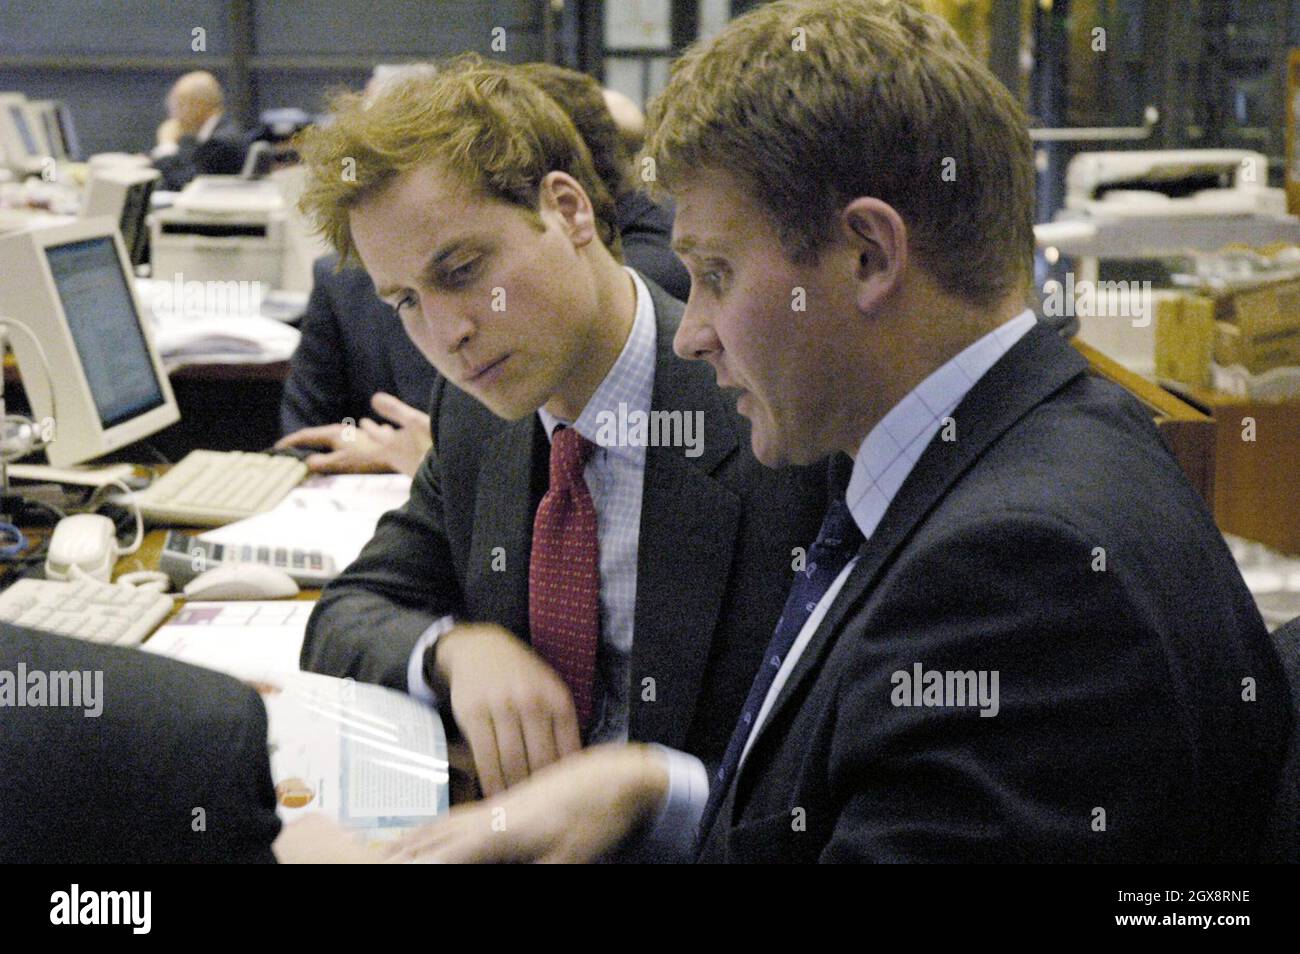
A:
[407,269,655,745]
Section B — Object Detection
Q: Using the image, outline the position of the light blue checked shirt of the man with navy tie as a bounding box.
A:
[646,311,1035,858]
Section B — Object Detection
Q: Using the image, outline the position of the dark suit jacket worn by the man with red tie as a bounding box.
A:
[302,285,826,762]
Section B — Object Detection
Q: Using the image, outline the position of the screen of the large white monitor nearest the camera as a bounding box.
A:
[46,235,165,430]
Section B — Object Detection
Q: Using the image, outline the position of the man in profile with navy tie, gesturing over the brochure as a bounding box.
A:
[390,0,1292,862]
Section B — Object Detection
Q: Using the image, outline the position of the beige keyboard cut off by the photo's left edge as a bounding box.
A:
[0,580,172,646]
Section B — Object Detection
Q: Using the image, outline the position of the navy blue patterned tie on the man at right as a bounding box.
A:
[699,499,863,836]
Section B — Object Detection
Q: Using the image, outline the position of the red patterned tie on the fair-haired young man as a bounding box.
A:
[528,428,601,728]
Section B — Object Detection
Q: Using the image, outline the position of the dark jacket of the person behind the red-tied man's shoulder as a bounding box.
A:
[280,255,438,434]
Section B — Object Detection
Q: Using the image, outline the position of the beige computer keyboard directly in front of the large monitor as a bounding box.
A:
[137,451,307,526]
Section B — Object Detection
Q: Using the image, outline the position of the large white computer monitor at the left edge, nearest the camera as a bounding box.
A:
[0,217,181,467]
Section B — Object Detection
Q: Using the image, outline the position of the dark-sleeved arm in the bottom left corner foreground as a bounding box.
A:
[0,624,280,864]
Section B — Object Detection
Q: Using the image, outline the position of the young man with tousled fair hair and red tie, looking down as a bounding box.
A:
[295,57,826,792]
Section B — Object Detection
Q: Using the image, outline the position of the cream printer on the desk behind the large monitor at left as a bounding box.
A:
[150,175,286,289]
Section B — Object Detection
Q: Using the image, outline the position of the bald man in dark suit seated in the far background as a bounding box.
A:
[153,70,248,191]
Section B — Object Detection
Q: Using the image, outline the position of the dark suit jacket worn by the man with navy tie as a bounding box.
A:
[701,321,1291,862]
